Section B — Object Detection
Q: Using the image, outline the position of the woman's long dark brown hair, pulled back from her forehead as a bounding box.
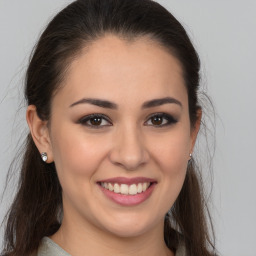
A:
[3,0,215,256]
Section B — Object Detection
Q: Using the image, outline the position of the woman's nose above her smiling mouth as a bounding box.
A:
[109,127,149,170]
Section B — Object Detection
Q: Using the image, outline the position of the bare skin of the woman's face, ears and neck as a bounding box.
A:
[27,35,200,256]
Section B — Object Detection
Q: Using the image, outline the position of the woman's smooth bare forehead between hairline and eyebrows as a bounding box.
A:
[54,35,187,107]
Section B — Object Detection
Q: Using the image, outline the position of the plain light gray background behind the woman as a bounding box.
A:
[0,0,256,256]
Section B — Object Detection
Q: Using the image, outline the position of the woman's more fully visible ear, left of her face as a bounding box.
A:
[26,105,53,163]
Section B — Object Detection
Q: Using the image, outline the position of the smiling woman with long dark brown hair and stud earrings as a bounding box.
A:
[3,0,214,256]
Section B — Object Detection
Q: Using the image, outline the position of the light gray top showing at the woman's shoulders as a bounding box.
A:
[36,237,185,256]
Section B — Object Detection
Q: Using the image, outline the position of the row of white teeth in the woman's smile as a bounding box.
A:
[101,182,150,195]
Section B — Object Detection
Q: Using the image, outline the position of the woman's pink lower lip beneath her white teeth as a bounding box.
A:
[99,183,156,206]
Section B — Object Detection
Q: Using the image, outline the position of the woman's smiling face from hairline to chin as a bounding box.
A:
[49,35,196,237]
